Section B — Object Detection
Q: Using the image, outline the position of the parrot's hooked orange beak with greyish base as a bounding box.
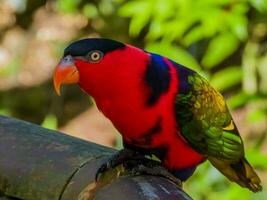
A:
[54,55,80,95]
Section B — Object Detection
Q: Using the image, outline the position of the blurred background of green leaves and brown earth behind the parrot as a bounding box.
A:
[0,0,267,200]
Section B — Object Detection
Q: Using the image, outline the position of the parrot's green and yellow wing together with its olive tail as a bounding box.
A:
[175,73,262,192]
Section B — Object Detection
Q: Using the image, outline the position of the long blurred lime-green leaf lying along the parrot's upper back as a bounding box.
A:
[146,43,201,71]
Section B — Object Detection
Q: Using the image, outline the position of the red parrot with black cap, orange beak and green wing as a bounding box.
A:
[53,38,262,192]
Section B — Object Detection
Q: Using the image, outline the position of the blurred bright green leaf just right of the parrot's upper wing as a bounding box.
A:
[210,66,242,91]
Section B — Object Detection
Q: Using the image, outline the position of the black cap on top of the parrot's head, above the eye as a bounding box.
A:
[64,38,125,56]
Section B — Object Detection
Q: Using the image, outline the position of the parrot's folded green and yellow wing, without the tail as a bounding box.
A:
[175,74,244,160]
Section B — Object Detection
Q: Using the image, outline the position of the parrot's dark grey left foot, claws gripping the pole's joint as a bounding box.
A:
[95,149,145,182]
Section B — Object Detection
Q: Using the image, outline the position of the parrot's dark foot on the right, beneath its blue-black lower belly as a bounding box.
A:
[132,164,182,187]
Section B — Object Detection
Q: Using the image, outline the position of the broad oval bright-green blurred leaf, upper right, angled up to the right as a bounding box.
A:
[201,32,239,68]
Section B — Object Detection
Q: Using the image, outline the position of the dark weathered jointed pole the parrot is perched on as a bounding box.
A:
[0,116,191,200]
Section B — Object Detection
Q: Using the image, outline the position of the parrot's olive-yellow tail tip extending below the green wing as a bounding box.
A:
[209,157,262,192]
